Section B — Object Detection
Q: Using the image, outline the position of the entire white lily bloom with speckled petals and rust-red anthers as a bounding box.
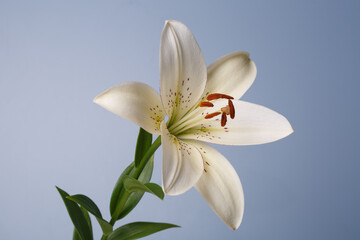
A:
[94,20,293,230]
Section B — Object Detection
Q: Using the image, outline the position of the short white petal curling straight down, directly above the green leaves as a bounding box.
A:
[161,121,204,195]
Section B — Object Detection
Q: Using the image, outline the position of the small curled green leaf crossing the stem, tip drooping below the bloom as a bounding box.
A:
[124,176,164,200]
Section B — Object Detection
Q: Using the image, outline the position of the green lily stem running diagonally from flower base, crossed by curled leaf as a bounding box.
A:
[110,136,161,225]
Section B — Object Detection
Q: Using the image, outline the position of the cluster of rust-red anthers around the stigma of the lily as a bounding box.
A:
[199,93,235,127]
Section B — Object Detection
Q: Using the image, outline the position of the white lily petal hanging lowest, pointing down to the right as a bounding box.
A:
[189,140,244,230]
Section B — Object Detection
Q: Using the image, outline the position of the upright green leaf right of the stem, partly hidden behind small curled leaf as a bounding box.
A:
[118,155,154,219]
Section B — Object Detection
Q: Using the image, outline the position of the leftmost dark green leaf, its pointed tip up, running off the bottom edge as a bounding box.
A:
[56,187,93,240]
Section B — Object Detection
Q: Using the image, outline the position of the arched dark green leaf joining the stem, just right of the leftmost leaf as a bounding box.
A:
[66,194,113,234]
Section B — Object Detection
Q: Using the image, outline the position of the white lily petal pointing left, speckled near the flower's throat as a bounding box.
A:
[94,82,165,135]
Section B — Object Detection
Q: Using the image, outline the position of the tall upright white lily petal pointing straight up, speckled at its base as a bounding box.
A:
[160,20,207,122]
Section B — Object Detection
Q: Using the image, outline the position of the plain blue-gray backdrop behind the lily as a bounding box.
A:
[0,0,360,240]
